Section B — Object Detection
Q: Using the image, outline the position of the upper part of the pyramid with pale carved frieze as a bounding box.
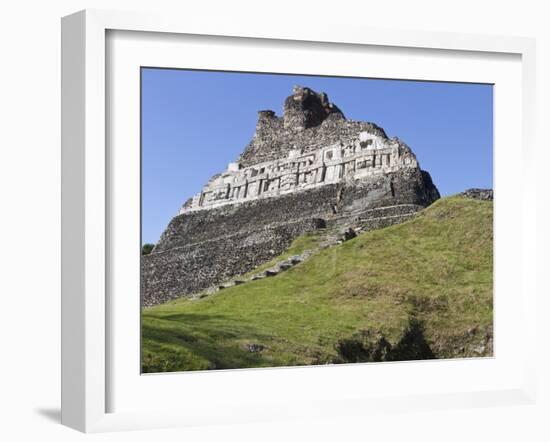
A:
[180,87,431,214]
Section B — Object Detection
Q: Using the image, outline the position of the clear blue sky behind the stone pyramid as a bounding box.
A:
[142,68,493,243]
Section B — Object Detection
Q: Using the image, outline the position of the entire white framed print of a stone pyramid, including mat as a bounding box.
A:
[62,11,536,431]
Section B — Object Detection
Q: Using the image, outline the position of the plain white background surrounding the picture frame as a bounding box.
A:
[0,0,550,441]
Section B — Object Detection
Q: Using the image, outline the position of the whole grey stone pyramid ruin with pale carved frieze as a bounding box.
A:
[141,86,439,306]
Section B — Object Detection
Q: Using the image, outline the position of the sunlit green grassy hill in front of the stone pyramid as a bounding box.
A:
[142,196,493,372]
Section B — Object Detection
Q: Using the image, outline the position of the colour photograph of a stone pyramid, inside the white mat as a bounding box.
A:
[140,66,494,373]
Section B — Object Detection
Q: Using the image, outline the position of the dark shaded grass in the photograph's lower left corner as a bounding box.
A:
[141,313,280,373]
